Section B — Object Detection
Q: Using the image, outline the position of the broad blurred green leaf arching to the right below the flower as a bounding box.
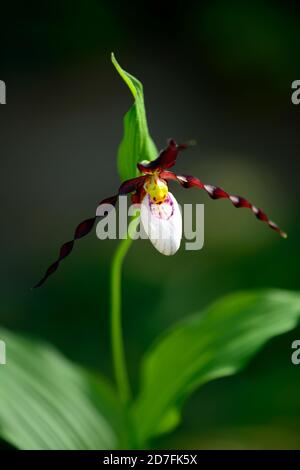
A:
[134,290,300,443]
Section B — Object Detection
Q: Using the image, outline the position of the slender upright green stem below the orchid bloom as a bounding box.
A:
[111,217,138,404]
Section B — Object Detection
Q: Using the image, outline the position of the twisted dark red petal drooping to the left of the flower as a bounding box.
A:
[34,176,146,288]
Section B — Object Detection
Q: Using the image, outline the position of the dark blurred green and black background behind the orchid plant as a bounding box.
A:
[0,0,300,448]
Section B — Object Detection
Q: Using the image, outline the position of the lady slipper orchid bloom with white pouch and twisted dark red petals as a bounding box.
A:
[35,139,287,287]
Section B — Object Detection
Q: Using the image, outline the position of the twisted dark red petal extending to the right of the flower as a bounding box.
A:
[160,171,287,238]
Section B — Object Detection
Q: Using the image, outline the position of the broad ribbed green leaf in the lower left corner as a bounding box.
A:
[0,329,117,450]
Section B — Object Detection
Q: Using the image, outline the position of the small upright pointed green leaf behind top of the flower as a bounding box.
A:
[111,54,158,181]
